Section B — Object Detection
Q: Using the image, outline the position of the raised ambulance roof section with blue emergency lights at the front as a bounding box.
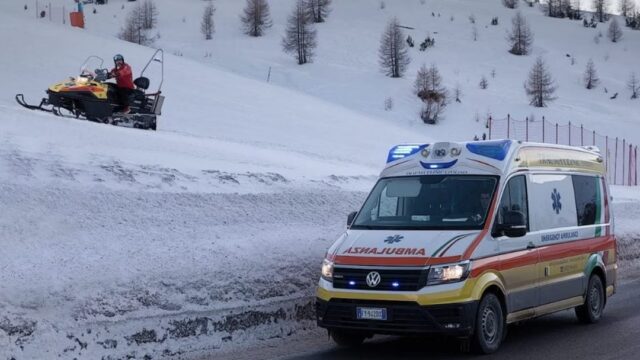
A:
[381,140,605,177]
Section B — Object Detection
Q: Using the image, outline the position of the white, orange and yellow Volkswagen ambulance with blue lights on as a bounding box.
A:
[316,140,617,353]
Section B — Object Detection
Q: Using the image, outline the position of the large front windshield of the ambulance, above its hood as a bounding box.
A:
[351,175,498,230]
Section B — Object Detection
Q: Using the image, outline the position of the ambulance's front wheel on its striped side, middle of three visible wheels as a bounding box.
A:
[472,293,506,354]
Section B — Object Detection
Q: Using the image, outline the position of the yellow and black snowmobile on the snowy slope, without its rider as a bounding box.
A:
[16,49,164,130]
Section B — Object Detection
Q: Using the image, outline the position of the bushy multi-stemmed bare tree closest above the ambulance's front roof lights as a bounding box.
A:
[413,64,448,124]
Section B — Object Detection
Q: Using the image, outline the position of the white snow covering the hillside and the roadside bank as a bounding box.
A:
[0,0,640,359]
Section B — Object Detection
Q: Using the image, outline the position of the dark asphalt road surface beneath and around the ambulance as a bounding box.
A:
[220,277,640,360]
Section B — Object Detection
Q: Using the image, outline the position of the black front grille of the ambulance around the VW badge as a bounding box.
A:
[333,267,427,291]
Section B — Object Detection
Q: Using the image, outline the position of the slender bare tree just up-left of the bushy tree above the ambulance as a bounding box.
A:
[378,18,411,78]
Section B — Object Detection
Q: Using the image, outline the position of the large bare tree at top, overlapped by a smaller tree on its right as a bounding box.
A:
[282,0,317,65]
